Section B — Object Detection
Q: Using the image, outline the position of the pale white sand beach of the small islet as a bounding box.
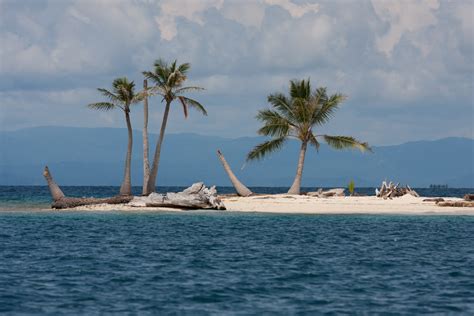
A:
[62,194,474,215]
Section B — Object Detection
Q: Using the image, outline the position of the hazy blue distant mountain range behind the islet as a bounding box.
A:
[0,127,474,188]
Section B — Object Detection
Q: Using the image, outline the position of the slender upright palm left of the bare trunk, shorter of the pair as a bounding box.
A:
[88,77,146,195]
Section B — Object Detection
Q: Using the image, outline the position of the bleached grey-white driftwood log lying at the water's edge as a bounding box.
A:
[127,182,226,210]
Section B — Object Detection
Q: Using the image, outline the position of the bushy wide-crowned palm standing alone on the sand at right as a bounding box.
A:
[247,79,371,194]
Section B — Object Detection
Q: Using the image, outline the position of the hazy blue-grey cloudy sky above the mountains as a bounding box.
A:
[0,0,474,145]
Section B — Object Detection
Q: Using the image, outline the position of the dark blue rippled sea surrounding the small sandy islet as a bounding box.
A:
[0,187,474,315]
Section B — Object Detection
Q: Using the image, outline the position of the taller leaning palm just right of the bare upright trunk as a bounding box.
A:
[143,59,207,194]
